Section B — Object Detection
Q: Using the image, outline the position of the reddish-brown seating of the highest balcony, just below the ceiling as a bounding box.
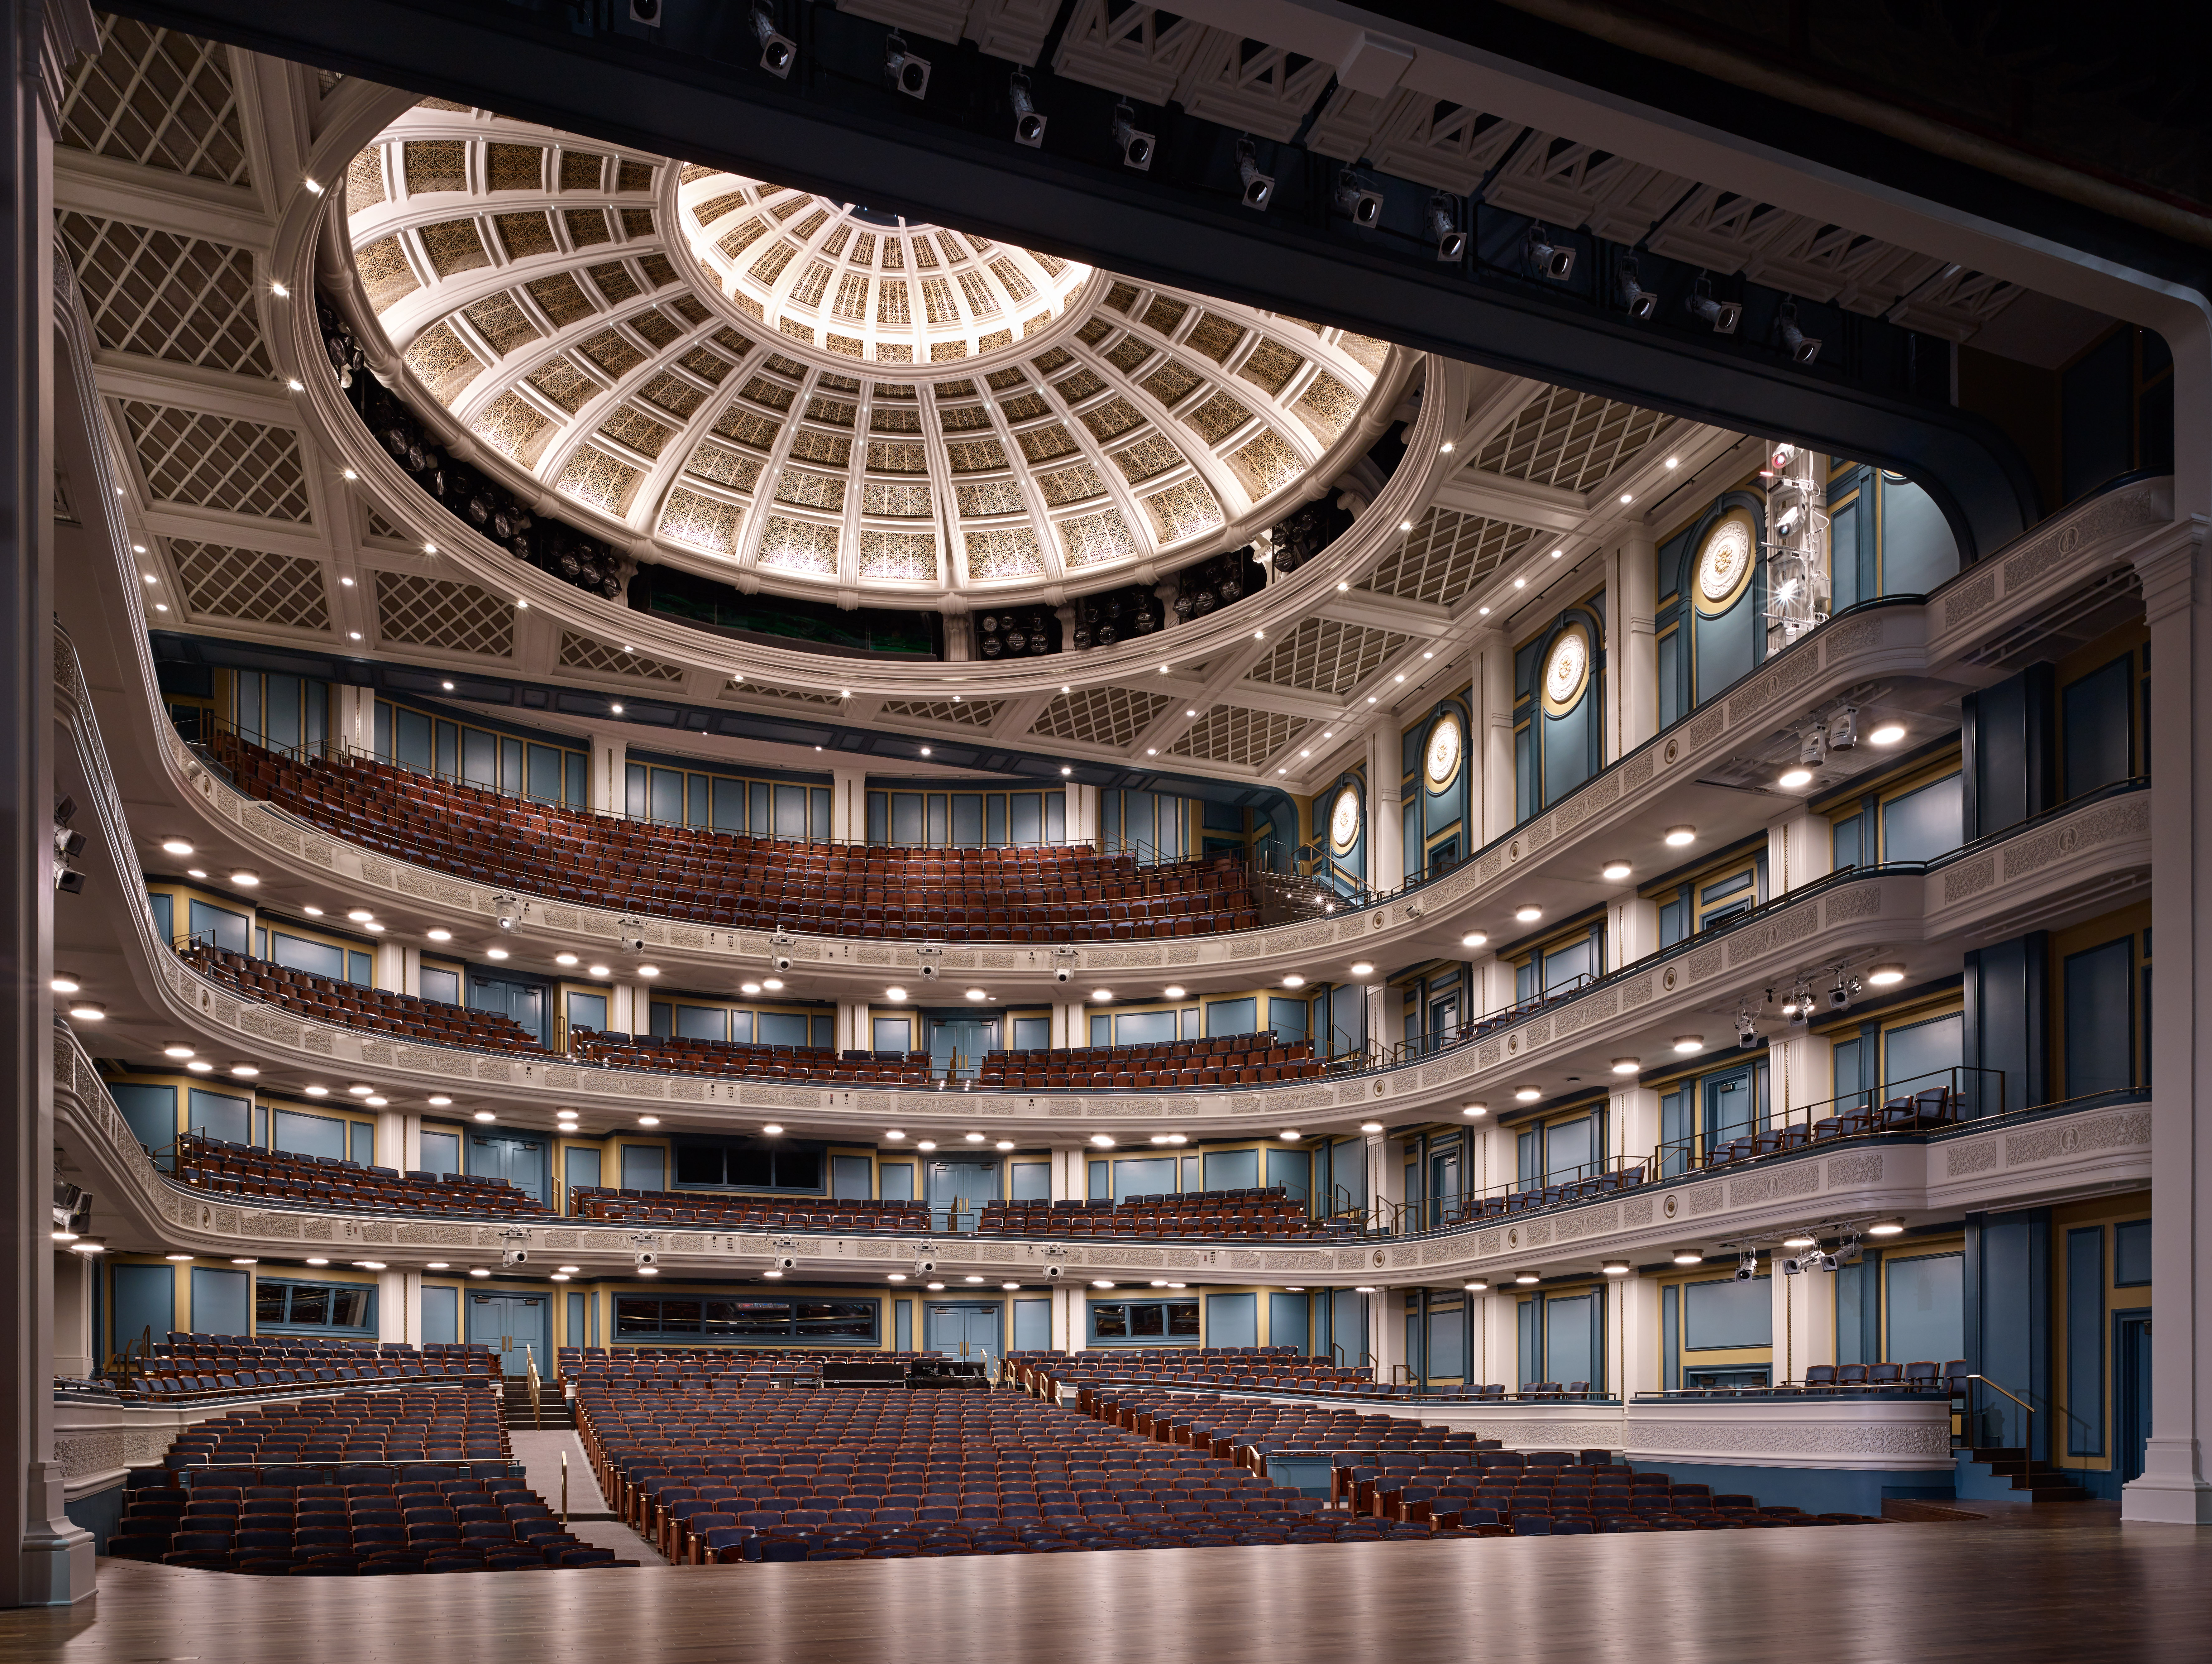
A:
[213,735,1259,942]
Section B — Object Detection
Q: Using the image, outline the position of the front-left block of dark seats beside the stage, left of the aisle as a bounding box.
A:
[108,1469,637,1578]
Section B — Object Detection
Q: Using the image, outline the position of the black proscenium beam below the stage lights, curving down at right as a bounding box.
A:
[115,0,2039,560]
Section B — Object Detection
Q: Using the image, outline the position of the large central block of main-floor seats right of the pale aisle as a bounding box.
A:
[577,1381,1431,1562]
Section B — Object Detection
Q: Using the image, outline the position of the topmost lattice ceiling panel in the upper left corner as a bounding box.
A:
[62,13,248,186]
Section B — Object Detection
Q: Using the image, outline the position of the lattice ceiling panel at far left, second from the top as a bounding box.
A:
[55,215,274,376]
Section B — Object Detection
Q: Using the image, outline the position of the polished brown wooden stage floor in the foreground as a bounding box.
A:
[0,1523,2212,1664]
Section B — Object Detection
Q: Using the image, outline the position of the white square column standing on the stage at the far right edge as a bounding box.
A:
[2121,529,2212,1525]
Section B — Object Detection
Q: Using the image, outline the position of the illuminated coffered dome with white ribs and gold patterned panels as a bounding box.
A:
[345,106,1391,604]
